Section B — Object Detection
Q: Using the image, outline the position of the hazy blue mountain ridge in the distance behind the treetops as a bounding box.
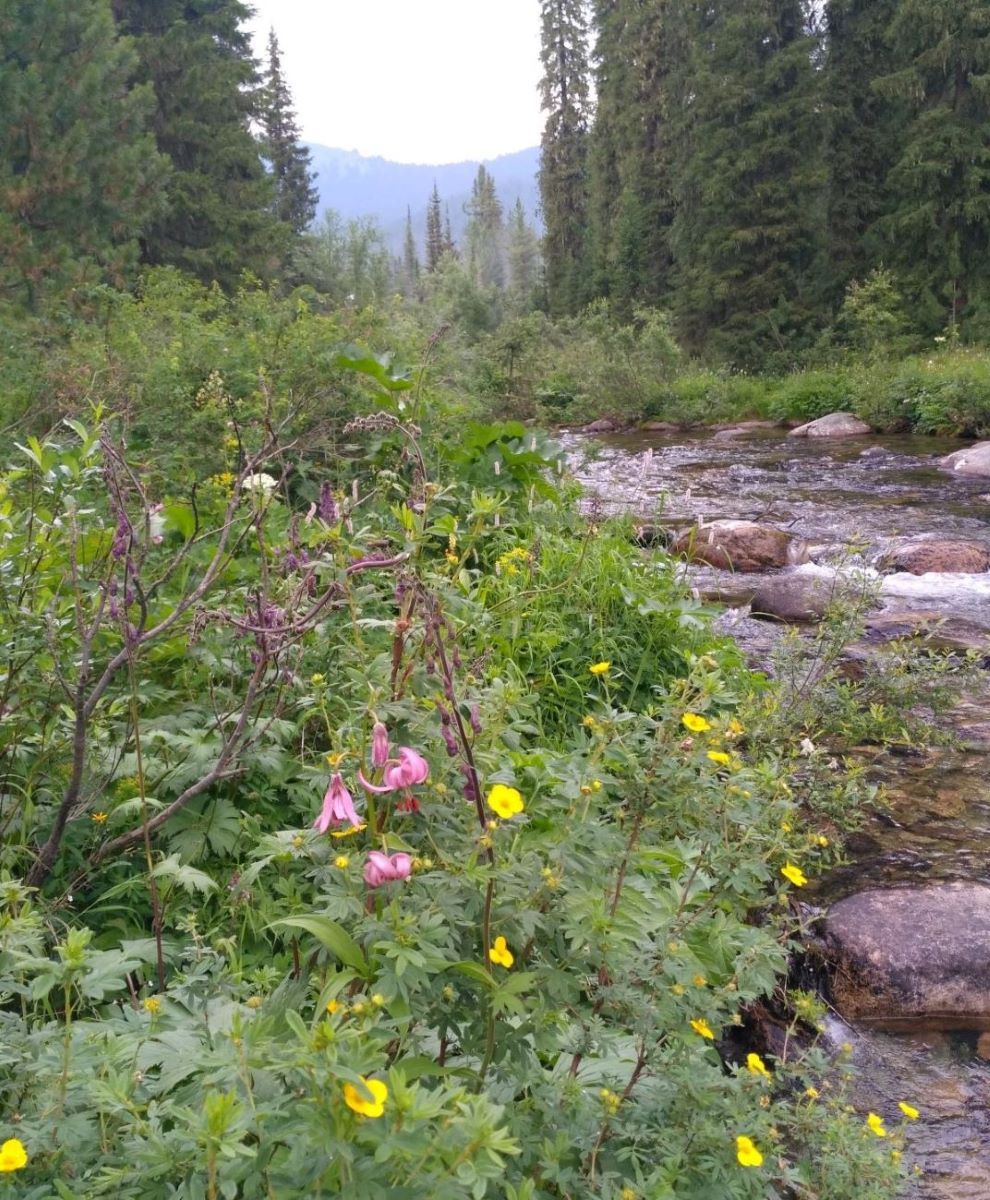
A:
[307,143,540,253]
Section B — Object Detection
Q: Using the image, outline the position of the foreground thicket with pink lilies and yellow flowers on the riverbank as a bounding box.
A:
[0,302,931,1200]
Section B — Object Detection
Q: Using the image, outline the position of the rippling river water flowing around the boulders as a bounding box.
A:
[563,428,990,1200]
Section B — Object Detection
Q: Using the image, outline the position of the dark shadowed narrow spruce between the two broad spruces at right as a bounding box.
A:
[821,0,907,311]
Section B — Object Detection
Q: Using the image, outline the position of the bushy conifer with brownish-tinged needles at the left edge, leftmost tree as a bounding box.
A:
[0,0,164,311]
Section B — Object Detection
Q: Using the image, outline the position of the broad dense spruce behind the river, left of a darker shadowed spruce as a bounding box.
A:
[672,0,821,366]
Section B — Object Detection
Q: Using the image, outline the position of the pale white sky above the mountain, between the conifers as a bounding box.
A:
[248,0,542,163]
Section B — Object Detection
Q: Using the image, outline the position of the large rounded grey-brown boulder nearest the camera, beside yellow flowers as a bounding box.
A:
[824,883,990,1030]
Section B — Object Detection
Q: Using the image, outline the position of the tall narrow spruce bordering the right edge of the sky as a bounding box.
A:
[540,0,590,313]
